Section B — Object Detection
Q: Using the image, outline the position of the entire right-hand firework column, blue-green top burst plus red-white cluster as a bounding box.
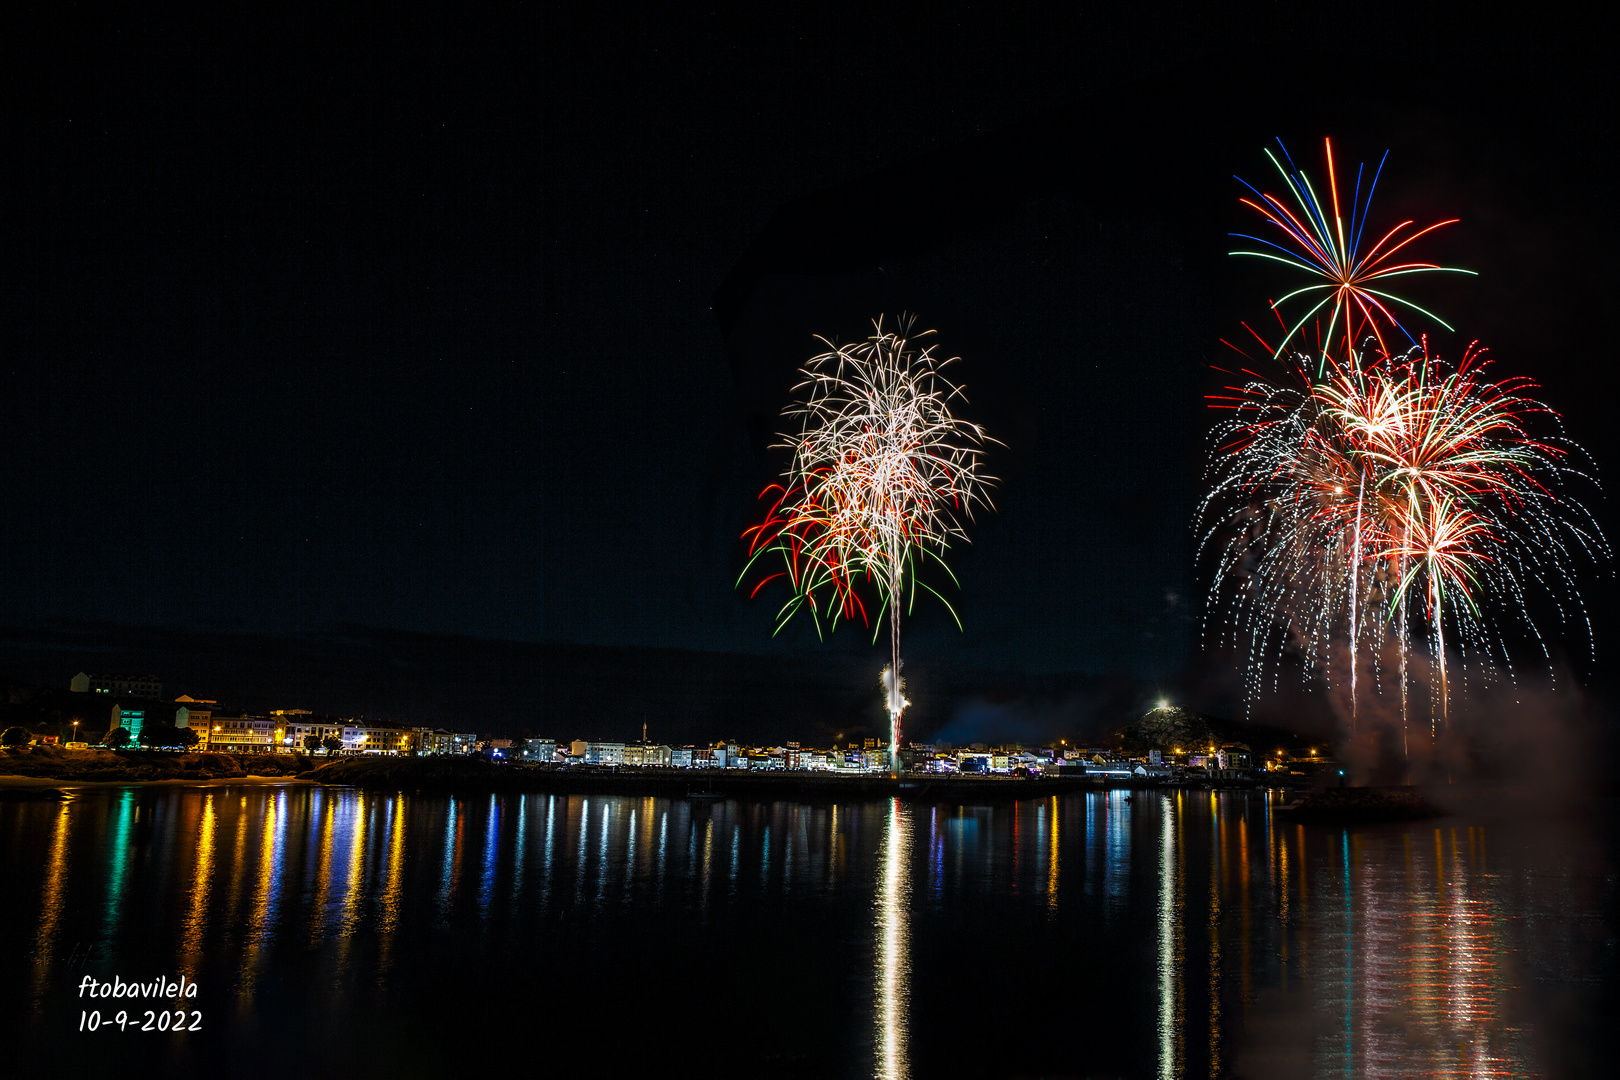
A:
[1199,141,1609,751]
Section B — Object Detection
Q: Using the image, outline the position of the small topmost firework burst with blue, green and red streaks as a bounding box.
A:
[1231,139,1473,365]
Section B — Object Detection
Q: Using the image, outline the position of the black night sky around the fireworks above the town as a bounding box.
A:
[0,5,1615,718]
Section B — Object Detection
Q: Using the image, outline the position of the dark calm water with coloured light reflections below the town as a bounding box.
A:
[0,785,1615,1077]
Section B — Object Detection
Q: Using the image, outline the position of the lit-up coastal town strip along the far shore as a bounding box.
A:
[5,672,1328,784]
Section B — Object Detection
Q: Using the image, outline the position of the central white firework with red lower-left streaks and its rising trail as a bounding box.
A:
[739,317,995,769]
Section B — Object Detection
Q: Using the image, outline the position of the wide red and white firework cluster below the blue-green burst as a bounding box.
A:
[1200,348,1607,735]
